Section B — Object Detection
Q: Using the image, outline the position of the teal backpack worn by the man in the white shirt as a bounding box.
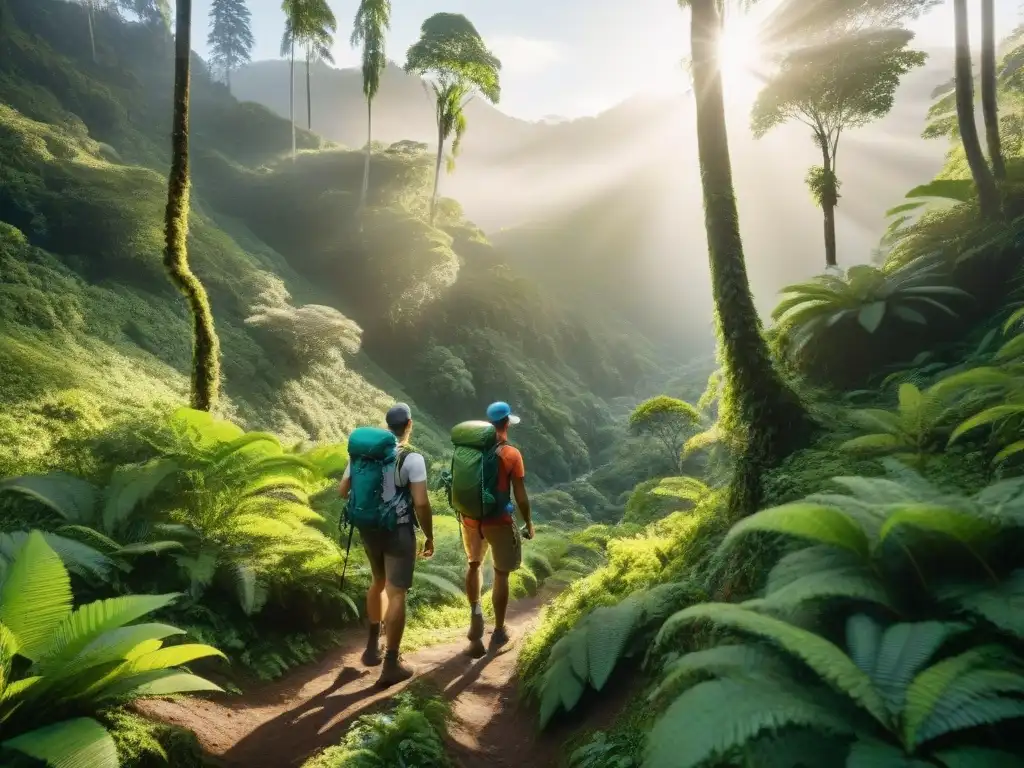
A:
[345,427,415,530]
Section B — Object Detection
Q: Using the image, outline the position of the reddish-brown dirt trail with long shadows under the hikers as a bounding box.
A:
[139,594,564,768]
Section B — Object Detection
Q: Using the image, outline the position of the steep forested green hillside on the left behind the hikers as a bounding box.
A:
[0,1,671,482]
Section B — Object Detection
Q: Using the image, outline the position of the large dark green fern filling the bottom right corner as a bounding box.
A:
[644,604,1024,768]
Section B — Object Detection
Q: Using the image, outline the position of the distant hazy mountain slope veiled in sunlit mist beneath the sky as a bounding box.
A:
[231,49,951,342]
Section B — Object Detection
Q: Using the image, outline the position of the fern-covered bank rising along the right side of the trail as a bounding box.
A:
[520,3,1024,768]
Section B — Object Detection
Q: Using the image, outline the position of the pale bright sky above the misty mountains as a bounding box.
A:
[194,0,1019,120]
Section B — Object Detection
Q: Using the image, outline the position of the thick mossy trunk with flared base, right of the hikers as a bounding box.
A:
[690,0,810,516]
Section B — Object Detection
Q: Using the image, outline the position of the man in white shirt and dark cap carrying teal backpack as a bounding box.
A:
[339,402,434,687]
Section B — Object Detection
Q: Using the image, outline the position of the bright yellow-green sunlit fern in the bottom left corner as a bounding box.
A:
[0,531,222,768]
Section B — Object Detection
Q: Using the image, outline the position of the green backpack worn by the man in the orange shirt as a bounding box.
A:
[444,421,511,520]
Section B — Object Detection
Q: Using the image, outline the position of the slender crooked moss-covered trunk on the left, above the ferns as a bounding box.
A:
[164,0,220,411]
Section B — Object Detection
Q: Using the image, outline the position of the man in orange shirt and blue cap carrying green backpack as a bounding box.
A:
[450,401,534,657]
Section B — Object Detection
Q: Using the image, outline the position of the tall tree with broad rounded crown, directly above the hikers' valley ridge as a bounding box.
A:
[406,13,502,223]
